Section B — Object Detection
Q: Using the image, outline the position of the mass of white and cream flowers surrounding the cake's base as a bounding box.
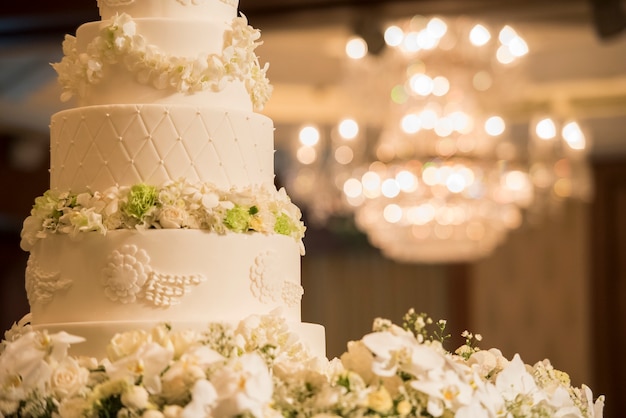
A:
[0,311,604,418]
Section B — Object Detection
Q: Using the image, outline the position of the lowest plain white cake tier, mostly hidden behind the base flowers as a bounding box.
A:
[34,316,326,359]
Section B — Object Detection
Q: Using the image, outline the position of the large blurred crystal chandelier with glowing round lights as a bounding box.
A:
[282,16,591,263]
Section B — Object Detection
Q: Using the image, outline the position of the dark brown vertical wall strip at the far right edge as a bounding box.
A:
[589,157,626,418]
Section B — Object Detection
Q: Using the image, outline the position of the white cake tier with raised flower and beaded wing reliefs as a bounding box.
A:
[26,229,303,326]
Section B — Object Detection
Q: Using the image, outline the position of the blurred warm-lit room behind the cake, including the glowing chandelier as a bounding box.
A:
[0,0,626,417]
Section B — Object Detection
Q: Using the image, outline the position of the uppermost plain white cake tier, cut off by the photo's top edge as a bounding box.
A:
[98,0,239,19]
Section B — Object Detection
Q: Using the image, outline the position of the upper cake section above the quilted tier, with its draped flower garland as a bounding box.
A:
[53,0,271,111]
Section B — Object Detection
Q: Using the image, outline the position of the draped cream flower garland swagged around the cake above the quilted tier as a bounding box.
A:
[52,14,272,110]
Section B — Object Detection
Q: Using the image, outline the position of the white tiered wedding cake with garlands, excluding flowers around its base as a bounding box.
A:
[17,0,325,356]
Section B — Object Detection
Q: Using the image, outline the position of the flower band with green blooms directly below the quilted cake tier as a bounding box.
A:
[21,180,306,254]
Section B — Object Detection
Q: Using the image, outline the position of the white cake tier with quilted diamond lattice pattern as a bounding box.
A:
[50,105,274,193]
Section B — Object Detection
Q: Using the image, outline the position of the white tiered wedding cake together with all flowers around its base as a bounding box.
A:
[0,0,604,418]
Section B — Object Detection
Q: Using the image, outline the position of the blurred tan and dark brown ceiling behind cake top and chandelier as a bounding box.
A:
[0,0,626,155]
